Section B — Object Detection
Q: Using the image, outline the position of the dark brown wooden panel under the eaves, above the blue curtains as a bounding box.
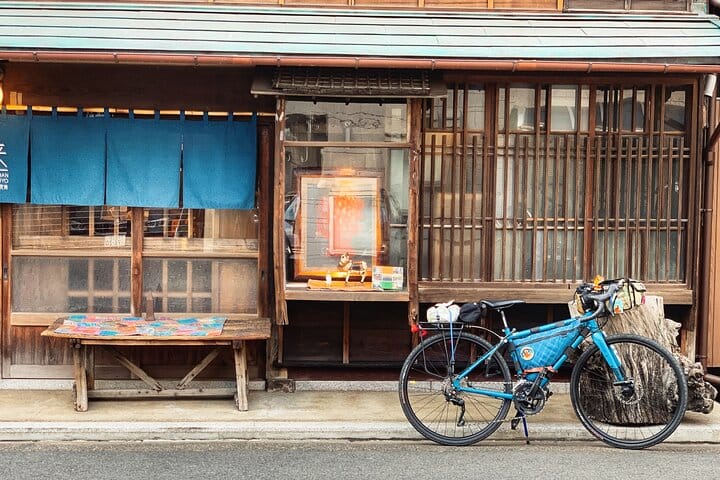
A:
[3,63,275,113]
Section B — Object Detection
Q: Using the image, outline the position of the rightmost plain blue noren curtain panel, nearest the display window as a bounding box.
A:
[183,116,257,209]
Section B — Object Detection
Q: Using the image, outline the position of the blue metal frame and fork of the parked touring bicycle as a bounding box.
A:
[449,310,625,400]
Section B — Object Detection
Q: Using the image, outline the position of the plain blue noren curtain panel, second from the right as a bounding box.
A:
[105,118,181,208]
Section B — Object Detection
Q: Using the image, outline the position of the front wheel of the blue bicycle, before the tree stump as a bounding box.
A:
[570,334,688,450]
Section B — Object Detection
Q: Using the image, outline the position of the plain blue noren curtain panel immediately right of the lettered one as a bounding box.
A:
[30,116,105,205]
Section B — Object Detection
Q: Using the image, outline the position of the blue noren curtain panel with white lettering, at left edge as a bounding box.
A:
[0,114,30,203]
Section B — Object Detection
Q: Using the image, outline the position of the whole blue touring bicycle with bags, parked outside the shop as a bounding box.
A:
[399,279,687,449]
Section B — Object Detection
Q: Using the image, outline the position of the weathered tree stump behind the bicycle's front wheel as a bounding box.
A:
[593,295,717,424]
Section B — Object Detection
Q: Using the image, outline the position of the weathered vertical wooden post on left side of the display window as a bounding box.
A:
[272,97,288,325]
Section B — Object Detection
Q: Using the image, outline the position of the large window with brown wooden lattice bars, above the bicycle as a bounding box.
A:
[421,84,694,283]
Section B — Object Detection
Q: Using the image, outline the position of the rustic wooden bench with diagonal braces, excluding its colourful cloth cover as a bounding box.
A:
[42,317,270,412]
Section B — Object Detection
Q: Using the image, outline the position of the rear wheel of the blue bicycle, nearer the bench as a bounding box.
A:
[398,332,512,446]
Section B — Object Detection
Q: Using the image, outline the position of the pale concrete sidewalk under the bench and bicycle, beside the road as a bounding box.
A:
[0,384,720,443]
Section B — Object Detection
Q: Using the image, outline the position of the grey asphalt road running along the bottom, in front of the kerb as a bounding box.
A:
[0,441,720,480]
